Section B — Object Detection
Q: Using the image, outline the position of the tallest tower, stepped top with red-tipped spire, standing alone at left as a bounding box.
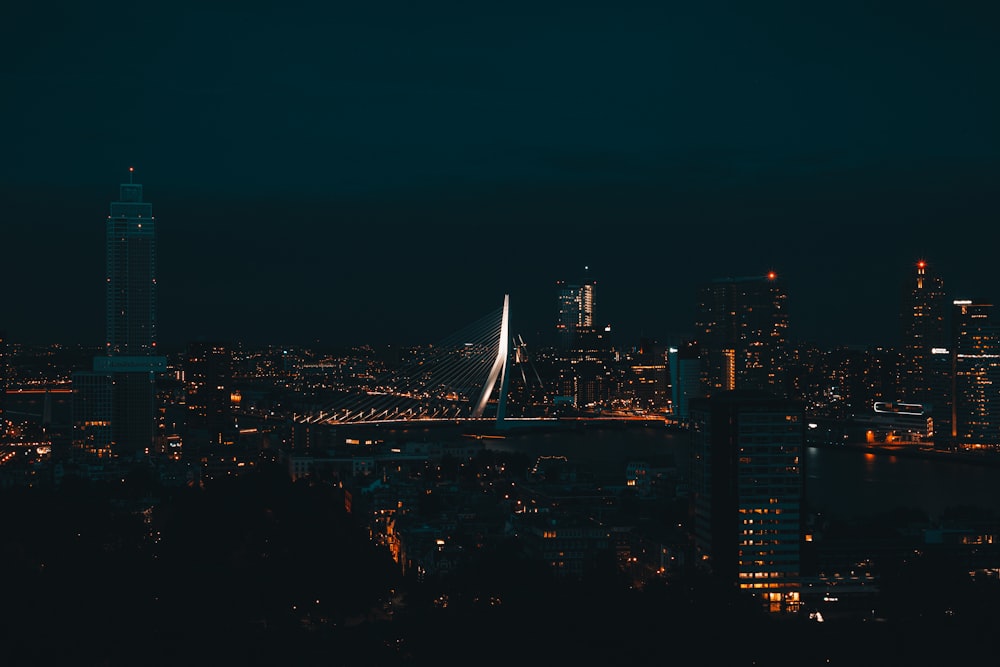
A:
[74,168,166,455]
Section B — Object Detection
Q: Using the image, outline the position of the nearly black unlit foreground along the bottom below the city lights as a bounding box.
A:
[0,466,1000,667]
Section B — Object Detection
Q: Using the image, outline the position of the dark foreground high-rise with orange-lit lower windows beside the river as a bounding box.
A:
[690,391,806,612]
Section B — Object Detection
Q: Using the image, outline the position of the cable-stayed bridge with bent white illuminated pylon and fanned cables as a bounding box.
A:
[295,295,541,426]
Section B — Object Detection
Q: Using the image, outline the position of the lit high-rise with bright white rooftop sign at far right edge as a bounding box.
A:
[950,299,1000,448]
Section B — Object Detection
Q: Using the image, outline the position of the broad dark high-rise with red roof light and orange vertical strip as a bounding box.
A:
[695,271,788,396]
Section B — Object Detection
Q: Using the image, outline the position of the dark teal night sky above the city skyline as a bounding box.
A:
[0,0,1000,352]
